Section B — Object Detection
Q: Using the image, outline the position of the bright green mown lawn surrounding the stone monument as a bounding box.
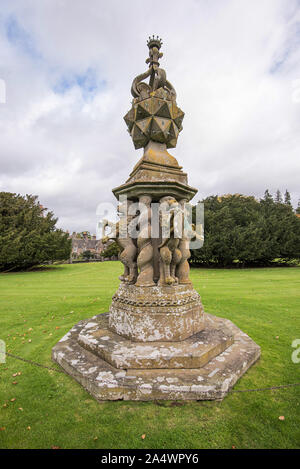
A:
[0,262,300,449]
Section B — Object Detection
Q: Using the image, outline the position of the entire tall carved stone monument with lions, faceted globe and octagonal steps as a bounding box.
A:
[52,36,260,400]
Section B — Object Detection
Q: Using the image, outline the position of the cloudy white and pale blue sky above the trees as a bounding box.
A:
[0,0,300,233]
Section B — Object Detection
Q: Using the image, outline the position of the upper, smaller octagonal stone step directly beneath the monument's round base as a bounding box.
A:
[78,314,233,369]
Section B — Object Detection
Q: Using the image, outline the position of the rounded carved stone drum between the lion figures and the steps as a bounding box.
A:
[109,284,204,342]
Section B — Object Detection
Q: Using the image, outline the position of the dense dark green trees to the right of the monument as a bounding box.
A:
[190,190,300,267]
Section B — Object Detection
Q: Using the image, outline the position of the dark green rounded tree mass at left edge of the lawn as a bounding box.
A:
[0,192,71,271]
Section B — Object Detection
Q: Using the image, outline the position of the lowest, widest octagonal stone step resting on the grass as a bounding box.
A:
[52,314,260,401]
